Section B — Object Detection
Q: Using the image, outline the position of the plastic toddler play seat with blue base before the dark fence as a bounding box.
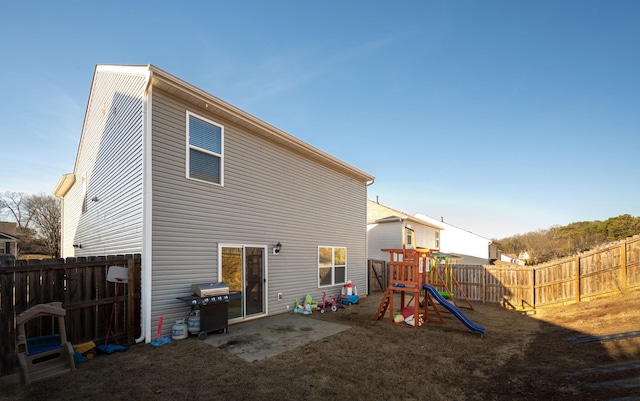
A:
[16,302,76,384]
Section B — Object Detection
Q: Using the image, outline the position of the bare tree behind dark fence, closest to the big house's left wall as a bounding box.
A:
[26,193,62,257]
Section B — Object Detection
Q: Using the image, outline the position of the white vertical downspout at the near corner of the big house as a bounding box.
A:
[135,69,153,343]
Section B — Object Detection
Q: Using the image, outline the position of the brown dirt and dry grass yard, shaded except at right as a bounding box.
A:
[0,291,640,401]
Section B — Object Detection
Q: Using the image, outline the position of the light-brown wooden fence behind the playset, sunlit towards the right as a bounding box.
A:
[368,236,640,308]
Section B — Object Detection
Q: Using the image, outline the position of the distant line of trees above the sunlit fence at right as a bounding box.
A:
[496,214,640,264]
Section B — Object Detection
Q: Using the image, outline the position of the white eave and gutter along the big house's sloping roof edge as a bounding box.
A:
[85,64,374,182]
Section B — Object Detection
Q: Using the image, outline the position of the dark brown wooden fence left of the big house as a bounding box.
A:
[0,254,141,376]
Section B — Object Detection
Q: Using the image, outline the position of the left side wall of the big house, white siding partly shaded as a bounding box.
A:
[62,70,147,257]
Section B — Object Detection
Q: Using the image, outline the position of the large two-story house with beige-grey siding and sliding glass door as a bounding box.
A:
[54,65,373,342]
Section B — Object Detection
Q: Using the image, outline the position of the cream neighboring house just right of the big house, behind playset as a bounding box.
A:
[367,200,442,260]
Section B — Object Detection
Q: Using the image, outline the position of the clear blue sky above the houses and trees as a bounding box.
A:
[0,0,640,238]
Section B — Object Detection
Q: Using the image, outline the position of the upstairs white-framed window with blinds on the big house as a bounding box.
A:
[187,112,224,185]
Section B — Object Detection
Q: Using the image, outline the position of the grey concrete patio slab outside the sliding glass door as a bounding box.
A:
[204,313,349,362]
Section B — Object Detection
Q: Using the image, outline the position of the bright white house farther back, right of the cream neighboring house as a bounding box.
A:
[414,213,498,265]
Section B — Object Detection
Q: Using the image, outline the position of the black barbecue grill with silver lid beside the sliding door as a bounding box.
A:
[178,282,239,340]
